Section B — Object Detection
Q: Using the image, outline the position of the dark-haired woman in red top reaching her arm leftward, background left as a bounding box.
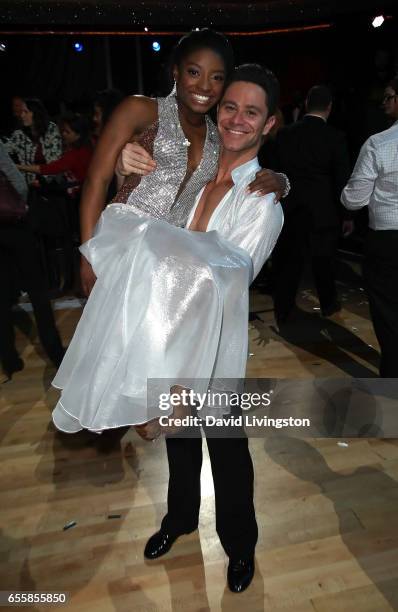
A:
[18,113,93,196]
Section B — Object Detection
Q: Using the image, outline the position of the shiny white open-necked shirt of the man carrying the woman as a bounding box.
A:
[186,157,283,278]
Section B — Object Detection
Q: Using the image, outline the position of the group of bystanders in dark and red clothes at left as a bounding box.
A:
[0,90,122,378]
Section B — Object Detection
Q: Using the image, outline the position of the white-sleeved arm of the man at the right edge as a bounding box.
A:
[341,138,378,210]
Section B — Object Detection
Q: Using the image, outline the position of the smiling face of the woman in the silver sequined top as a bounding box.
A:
[174,49,225,114]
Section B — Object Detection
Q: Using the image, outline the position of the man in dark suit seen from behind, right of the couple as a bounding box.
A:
[273,86,350,324]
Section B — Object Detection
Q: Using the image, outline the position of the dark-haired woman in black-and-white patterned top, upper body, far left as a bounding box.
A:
[4,98,62,184]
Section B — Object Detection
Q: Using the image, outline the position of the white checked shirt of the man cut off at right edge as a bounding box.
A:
[341,121,398,230]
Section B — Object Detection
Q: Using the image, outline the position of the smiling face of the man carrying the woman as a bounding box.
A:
[217,81,275,155]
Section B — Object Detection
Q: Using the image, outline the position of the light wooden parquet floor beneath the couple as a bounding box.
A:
[0,268,398,612]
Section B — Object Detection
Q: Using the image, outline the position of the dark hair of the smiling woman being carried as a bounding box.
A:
[170,28,234,76]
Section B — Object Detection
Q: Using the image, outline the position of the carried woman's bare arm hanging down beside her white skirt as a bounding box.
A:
[80,97,157,295]
